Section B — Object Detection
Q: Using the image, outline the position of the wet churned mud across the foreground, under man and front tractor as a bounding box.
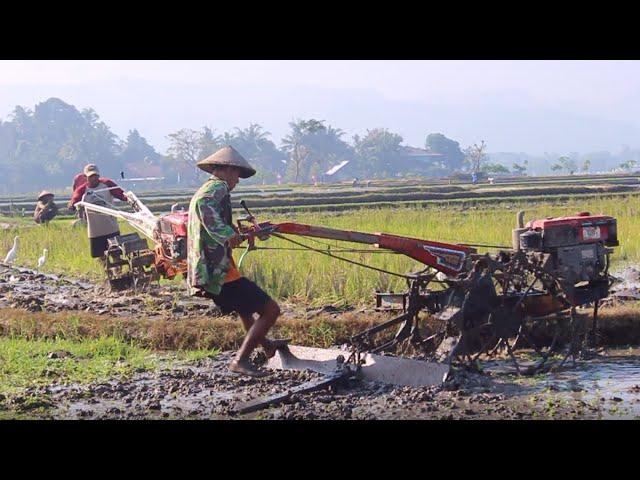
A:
[6,349,640,420]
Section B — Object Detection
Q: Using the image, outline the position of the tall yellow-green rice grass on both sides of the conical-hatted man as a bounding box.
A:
[0,188,640,306]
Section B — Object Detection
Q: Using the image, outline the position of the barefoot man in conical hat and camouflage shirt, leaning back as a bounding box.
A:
[187,147,286,377]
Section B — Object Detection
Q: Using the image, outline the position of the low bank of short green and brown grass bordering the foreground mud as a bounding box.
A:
[0,302,640,410]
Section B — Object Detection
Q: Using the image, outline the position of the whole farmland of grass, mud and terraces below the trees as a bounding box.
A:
[0,178,640,420]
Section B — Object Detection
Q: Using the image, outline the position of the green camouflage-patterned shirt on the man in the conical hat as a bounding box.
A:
[187,177,235,295]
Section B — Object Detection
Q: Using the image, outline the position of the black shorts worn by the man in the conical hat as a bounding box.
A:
[205,277,271,315]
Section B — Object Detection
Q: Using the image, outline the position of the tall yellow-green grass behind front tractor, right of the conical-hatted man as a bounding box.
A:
[242,196,640,304]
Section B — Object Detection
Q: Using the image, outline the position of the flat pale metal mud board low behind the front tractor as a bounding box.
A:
[267,345,449,387]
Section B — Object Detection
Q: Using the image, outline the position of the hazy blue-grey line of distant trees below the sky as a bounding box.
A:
[0,98,640,194]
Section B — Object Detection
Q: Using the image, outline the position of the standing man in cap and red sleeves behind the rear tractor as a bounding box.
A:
[69,164,127,258]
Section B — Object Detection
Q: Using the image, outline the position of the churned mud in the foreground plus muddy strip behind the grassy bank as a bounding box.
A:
[0,266,640,419]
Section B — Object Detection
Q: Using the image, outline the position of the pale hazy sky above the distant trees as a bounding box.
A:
[0,60,640,154]
